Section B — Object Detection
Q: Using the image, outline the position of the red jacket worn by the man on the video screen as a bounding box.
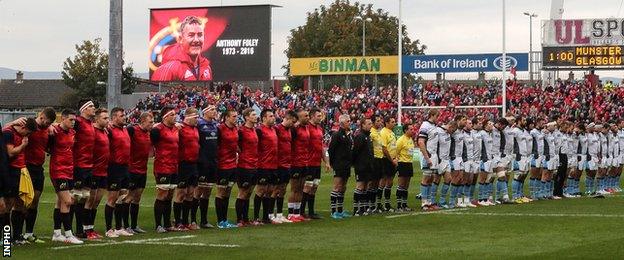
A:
[152,44,212,81]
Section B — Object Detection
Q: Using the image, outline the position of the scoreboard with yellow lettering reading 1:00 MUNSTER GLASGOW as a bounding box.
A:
[542,45,624,69]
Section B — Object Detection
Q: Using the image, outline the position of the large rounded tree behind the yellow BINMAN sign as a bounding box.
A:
[283,0,427,86]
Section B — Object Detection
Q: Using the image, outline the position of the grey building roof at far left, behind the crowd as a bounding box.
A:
[0,79,72,109]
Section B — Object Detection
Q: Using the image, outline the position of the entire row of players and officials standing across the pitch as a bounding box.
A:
[0,100,624,244]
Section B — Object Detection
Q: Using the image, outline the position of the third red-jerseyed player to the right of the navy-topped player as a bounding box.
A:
[254,109,277,224]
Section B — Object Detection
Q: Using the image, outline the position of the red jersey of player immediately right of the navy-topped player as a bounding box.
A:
[217,124,238,170]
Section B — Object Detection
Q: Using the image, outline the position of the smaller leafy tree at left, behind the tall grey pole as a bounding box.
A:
[61,38,137,107]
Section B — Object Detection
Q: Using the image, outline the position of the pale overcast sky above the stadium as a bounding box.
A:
[0,0,624,79]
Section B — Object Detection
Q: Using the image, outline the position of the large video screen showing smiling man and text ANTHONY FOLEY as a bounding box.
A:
[149,5,271,81]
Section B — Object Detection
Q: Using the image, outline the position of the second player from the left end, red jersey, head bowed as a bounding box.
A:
[24,107,56,243]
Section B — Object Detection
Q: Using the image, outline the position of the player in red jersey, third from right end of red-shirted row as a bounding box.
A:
[269,110,297,224]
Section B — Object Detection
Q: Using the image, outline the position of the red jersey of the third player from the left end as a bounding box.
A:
[49,126,75,180]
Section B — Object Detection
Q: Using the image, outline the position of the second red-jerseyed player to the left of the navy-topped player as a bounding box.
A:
[150,107,180,233]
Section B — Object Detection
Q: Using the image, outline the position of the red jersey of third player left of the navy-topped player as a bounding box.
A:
[127,125,152,174]
